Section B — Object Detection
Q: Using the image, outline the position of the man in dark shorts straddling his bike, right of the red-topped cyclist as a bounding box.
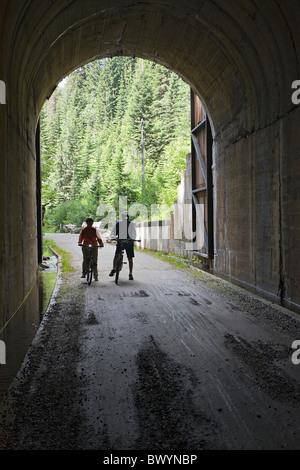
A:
[109,212,136,281]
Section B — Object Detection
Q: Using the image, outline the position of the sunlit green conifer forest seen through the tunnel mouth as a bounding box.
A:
[40,57,190,231]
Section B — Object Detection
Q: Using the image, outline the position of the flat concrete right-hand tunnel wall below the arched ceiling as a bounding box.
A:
[214,109,300,310]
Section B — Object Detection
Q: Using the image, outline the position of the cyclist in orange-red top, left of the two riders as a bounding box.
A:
[78,217,104,281]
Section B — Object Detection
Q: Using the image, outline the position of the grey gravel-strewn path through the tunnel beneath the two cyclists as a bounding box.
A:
[0,234,300,450]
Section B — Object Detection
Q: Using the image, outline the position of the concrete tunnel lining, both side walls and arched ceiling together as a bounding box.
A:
[0,0,300,330]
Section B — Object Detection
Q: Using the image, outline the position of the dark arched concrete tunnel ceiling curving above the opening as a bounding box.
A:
[0,0,300,138]
